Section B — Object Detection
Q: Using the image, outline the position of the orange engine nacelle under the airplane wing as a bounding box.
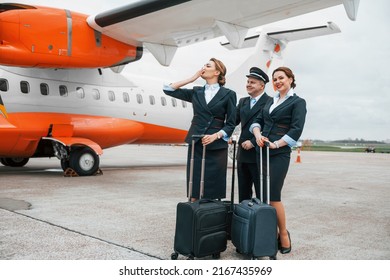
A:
[0,4,143,68]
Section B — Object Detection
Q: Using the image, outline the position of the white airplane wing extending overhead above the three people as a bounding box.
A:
[87,0,359,65]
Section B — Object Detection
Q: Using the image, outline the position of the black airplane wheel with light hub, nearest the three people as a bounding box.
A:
[69,147,99,176]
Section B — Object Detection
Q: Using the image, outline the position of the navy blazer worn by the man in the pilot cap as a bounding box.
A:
[236,93,272,163]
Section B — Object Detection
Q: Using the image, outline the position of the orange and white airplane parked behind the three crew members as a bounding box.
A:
[0,0,359,176]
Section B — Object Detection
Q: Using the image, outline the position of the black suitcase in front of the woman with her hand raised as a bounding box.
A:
[171,135,227,260]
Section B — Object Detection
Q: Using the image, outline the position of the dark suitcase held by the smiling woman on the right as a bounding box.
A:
[231,143,278,259]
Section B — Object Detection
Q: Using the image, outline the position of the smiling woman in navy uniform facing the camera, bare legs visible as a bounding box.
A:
[250,67,306,254]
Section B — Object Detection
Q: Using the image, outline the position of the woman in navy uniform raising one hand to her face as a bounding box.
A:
[164,58,237,201]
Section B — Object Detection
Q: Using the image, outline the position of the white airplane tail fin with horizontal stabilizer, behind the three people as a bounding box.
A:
[225,22,341,95]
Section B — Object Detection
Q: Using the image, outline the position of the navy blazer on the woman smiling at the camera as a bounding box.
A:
[254,94,307,155]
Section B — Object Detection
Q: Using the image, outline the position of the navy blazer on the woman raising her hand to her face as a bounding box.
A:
[164,86,237,150]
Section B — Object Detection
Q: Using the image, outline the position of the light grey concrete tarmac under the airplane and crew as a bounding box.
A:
[0,145,390,260]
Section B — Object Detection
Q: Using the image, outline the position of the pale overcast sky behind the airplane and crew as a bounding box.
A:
[9,0,390,140]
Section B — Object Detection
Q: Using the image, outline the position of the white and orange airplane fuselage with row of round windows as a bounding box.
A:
[0,64,192,157]
